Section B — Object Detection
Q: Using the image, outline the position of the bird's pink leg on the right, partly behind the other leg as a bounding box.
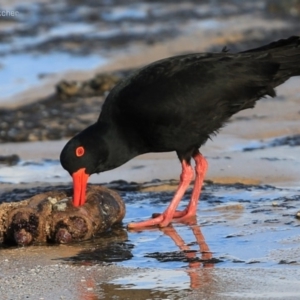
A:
[174,151,208,221]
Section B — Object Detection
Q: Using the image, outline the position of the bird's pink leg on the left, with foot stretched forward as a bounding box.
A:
[128,160,194,229]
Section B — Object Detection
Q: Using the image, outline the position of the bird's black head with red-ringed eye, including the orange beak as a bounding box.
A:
[60,125,108,206]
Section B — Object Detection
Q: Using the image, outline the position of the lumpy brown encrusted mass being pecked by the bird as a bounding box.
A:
[0,186,125,246]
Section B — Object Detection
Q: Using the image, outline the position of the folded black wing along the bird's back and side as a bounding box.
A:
[100,52,279,151]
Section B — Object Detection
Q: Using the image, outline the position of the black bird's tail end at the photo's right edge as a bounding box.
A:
[241,36,300,86]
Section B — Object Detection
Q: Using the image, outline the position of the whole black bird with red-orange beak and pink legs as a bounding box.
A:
[60,36,300,228]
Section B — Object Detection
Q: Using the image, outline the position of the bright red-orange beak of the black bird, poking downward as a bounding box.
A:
[72,168,89,206]
